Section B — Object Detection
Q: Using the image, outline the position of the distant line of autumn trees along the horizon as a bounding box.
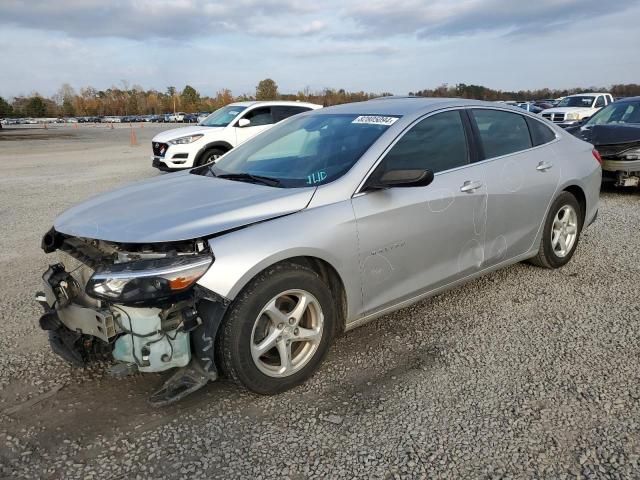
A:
[0,78,640,118]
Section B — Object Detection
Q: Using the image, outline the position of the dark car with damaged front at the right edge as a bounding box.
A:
[567,97,640,187]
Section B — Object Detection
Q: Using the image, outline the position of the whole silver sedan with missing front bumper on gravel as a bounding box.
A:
[38,97,601,405]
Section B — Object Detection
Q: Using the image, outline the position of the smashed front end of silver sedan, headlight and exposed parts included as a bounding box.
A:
[36,229,228,405]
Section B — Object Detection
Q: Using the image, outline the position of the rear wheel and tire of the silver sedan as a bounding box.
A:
[529,192,583,268]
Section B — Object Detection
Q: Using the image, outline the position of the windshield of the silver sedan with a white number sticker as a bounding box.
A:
[194,114,399,188]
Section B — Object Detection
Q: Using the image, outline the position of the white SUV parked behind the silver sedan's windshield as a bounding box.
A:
[151,101,322,171]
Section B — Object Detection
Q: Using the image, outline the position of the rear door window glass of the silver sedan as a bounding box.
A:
[471,109,532,158]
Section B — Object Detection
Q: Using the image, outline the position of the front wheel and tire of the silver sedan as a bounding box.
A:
[218,263,337,395]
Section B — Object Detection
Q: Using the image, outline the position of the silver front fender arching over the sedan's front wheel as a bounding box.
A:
[198,200,362,321]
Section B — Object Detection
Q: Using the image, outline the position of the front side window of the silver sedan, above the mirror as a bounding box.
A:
[383,110,469,173]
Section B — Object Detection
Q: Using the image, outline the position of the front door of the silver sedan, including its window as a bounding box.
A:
[352,110,487,315]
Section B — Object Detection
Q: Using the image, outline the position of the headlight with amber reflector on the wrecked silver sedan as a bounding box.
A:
[86,255,213,303]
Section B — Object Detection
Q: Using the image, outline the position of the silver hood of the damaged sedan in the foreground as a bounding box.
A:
[54,171,315,243]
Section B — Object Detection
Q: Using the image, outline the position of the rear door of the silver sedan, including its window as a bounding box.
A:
[469,108,560,268]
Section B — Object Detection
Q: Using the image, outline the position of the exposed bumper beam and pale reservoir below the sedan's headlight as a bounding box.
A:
[36,264,191,372]
